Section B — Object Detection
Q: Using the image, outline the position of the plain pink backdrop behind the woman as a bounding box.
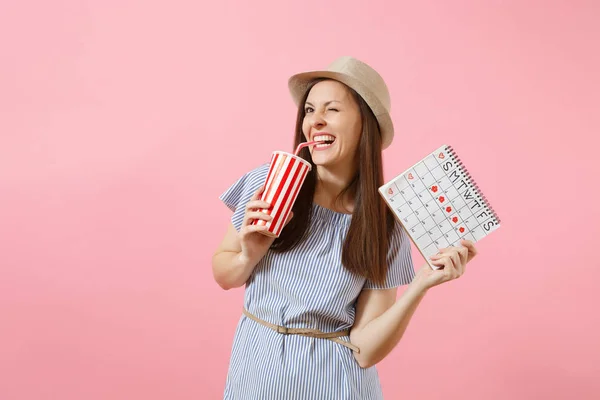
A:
[0,0,600,400]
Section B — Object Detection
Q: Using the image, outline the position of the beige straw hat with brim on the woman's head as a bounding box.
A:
[288,56,394,149]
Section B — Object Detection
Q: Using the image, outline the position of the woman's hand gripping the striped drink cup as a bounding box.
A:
[239,186,293,265]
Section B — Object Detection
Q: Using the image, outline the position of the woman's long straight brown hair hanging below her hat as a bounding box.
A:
[271,79,394,283]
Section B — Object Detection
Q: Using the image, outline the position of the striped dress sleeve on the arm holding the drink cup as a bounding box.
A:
[219,164,269,232]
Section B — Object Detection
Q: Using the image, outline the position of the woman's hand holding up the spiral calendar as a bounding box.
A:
[413,240,477,290]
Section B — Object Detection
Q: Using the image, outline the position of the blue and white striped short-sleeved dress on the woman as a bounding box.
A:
[220,164,414,400]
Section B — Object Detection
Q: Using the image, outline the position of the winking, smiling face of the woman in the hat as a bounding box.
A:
[302,80,362,167]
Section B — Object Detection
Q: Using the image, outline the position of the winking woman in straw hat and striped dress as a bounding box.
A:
[213,57,476,400]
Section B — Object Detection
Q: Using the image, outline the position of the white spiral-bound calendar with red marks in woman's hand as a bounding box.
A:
[379,145,500,269]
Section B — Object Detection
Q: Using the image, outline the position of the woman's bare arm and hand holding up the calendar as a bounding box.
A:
[350,240,477,368]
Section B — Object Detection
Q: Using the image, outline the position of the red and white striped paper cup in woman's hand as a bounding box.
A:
[253,151,312,237]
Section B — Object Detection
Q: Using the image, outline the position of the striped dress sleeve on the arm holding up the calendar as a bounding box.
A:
[363,221,415,289]
